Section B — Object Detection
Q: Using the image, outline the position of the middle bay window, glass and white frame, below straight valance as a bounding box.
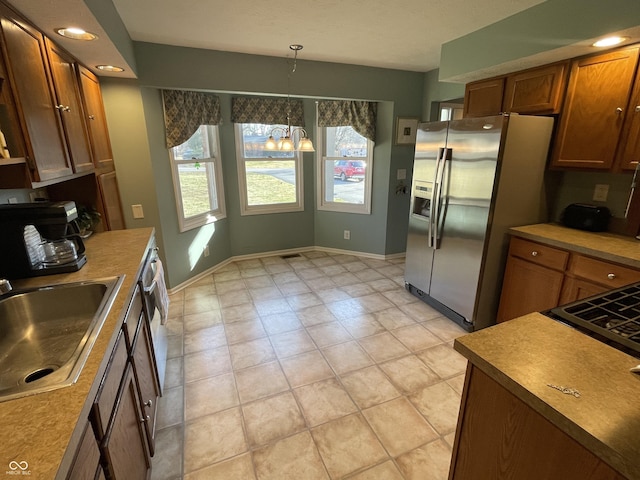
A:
[235,123,304,215]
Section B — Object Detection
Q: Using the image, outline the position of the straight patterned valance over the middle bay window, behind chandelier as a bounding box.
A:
[231,97,304,127]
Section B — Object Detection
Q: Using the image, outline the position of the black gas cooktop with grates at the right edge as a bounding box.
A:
[544,282,640,358]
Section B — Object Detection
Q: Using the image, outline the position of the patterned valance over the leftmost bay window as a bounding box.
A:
[162,90,222,148]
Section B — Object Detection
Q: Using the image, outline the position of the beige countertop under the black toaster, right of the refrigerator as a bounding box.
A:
[509,223,640,269]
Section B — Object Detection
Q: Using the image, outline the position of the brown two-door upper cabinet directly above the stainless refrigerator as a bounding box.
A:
[464,62,568,117]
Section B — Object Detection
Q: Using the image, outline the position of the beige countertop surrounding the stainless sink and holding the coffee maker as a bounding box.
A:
[0,228,154,480]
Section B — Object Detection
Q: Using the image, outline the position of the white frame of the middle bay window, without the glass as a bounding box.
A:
[234,123,304,216]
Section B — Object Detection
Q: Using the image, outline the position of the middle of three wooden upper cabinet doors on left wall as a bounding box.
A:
[46,39,93,172]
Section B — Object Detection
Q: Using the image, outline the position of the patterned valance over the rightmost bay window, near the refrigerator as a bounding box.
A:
[318,100,378,142]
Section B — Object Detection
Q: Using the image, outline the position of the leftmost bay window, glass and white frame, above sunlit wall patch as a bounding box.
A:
[169,125,226,232]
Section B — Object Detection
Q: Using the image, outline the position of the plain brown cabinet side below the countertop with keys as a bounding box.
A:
[449,364,625,480]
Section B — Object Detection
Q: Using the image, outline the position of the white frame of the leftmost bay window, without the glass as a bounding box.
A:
[168,125,227,232]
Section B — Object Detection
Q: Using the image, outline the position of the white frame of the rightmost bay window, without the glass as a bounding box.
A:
[316,126,375,215]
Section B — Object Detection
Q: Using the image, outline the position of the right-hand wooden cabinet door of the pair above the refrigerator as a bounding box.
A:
[502,62,568,114]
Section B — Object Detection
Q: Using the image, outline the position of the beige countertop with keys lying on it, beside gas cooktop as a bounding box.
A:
[454,313,640,480]
